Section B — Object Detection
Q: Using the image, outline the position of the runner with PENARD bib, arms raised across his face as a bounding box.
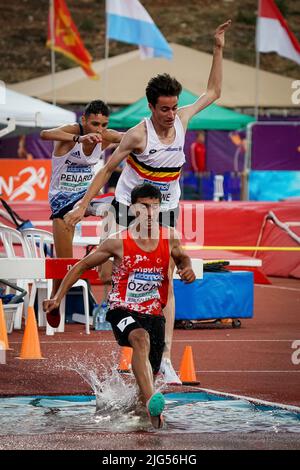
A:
[41,100,123,302]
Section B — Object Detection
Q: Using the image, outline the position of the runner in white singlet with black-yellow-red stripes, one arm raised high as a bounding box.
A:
[65,20,231,384]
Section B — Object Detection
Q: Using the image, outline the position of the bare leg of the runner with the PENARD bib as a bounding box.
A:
[51,219,74,298]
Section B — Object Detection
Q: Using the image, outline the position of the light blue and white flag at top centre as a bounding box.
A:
[106,0,173,59]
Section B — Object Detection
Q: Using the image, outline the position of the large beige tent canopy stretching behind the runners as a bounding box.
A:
[10,44,299,108]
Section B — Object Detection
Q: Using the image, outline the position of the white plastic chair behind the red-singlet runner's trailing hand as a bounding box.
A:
[22,228,90,335]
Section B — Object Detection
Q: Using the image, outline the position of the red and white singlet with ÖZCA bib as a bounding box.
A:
[108,227,170,315]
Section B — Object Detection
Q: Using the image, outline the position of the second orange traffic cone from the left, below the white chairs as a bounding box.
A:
[18,307,44,359]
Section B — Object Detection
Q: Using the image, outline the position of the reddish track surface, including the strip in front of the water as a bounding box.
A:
[0,278,300,449]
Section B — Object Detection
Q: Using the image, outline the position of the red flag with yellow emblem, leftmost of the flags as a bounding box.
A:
[47,0,99,79]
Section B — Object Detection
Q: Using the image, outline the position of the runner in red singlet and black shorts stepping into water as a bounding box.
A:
[44,183,195,428]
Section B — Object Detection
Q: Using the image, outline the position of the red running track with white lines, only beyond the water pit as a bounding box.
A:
[0,278,300,406]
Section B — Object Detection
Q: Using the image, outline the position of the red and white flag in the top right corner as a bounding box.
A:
[256,0,300,64]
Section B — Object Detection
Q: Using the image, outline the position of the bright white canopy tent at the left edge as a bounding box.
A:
[0,88,76,137]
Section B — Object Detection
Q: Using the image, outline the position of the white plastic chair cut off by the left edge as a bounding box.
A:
[0,224,32,330]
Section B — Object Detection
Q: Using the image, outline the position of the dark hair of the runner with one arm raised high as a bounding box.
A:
[146,73,182,106]
